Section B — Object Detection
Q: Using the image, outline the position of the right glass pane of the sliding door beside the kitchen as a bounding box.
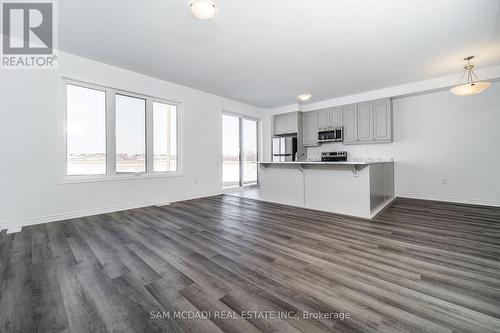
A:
[242,119,257,185]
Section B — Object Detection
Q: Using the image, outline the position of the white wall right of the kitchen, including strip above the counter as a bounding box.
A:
[265,82,500,206]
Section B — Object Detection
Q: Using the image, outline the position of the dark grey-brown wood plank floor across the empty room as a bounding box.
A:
[0,196,500,333]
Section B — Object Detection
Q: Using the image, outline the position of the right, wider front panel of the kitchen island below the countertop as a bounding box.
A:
[304,165,371,218]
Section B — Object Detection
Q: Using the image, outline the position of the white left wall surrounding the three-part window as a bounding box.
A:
[0,53,262,228]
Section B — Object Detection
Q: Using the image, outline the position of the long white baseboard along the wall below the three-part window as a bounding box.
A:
[0,193,221,233]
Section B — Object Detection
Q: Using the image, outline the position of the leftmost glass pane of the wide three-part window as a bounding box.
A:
[66,84,106,176]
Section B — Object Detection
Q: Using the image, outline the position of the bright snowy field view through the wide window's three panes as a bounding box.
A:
[66,84,178,176]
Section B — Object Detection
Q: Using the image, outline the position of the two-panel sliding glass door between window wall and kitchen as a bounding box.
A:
[222,114,258,188]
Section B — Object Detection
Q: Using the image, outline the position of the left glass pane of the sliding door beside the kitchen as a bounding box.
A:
[222,115,240,188]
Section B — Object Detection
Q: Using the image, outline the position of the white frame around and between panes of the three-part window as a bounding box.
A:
[58,77,183,184]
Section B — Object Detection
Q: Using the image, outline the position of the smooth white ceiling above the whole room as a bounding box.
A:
[59,0,500,107]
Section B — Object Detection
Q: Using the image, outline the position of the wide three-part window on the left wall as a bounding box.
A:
[62,80,179,182]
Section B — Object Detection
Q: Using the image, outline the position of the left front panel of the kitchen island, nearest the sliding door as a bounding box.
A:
[259,164,304,207]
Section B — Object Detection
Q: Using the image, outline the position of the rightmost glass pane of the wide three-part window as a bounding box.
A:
[153,102,177,172]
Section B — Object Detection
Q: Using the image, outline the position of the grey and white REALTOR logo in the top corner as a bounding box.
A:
[2,1,57,68]
